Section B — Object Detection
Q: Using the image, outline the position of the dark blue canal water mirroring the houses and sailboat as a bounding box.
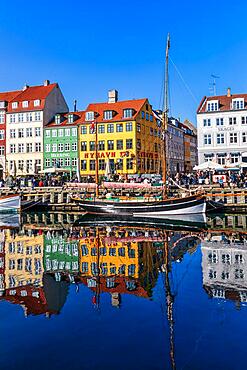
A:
[0,213,247,370]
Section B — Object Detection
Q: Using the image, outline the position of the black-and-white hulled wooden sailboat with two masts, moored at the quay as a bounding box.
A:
[74,34,206,219]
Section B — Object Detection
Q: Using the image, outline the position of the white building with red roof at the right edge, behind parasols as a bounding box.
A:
[197,89,247,166]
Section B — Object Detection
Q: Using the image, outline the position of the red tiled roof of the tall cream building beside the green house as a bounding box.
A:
[9,83,58,112]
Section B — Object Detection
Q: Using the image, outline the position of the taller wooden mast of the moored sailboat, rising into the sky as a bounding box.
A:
[162,33,170,198]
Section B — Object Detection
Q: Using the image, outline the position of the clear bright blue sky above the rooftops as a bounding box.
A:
[0,0,247,121]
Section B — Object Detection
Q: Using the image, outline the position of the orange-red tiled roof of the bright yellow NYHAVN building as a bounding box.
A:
[87,99,147,122]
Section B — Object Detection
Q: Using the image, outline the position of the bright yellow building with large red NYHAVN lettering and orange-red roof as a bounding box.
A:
[79,90,161,176]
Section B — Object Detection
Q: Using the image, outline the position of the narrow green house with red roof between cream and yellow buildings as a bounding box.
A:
[44,112,83,176]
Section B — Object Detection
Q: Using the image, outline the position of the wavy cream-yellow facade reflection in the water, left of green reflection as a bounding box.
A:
[4,230,44,289]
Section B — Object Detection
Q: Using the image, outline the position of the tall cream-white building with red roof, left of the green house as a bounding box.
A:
[6,80,68,176]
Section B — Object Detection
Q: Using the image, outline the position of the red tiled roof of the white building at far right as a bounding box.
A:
[197,94,247,113]
